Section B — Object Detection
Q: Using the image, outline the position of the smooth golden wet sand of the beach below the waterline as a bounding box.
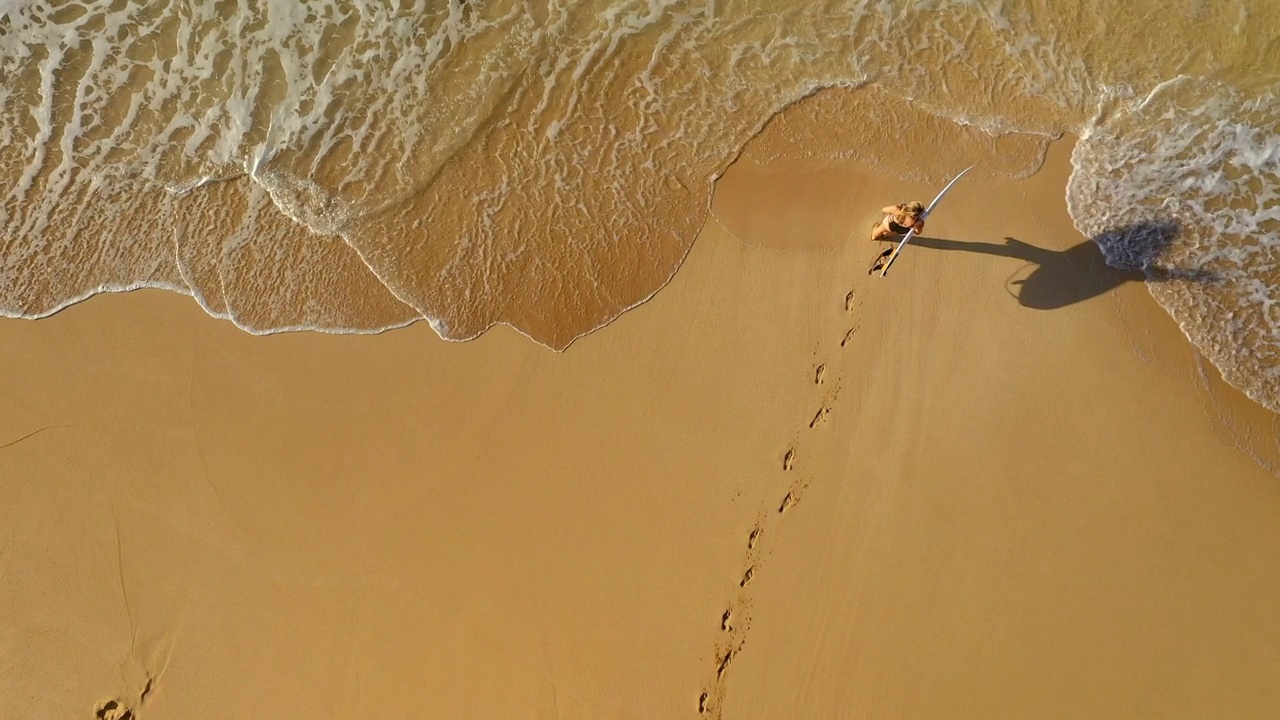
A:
[0,130,1280,720]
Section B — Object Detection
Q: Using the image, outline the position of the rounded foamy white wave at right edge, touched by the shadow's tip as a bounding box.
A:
[1068,77,1280,411]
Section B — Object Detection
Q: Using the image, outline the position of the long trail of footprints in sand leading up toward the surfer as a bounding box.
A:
[698,291,858,719]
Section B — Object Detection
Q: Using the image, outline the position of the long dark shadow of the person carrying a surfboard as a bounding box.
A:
[911,222,1215,310]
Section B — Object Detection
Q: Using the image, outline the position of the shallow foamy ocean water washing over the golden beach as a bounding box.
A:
[0,0,1280,410]
